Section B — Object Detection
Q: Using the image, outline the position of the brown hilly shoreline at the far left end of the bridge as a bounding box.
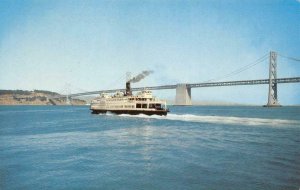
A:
[0,90,86,105]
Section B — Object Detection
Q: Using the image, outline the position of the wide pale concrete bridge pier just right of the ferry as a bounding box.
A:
[175,84,192,106]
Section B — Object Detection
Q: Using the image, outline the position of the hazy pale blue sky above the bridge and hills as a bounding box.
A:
[0,0,300,104]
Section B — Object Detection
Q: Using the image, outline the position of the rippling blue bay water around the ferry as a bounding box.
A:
[0,106,300,190]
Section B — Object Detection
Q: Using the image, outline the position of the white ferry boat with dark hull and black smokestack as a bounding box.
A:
[90,82,169,115]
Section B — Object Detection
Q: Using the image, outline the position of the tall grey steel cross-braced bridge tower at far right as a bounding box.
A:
[265,51,280,107]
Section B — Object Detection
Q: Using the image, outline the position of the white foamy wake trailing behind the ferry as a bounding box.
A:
[119,114,300,127]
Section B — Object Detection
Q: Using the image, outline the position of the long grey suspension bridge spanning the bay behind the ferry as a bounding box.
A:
[52,51,300,107]
